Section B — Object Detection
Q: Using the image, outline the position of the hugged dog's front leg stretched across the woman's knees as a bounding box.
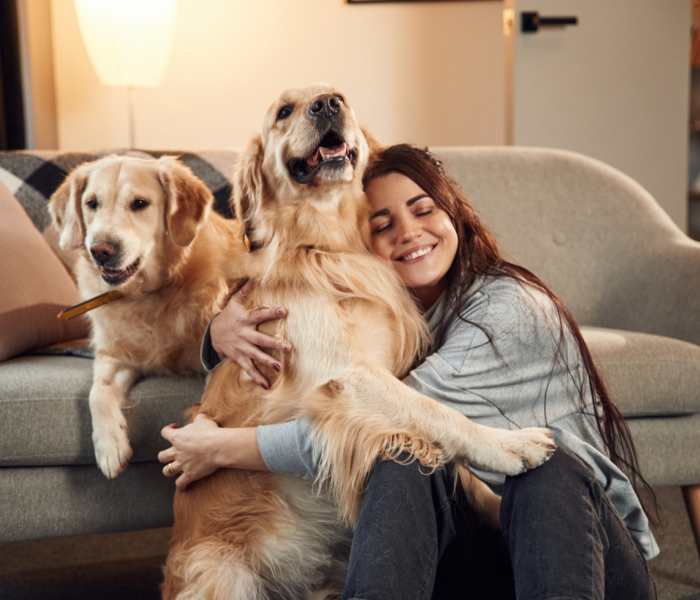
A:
[312,365,556,522]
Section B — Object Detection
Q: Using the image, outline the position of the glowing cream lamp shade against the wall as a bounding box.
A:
[75,0,177,87]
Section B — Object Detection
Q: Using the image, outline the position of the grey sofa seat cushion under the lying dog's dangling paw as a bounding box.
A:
[0,356,204,466]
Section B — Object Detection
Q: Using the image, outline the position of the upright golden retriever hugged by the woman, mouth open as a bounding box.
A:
[162,85,553,600]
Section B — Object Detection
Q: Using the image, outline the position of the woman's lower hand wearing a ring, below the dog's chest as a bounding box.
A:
[158,414,222,490]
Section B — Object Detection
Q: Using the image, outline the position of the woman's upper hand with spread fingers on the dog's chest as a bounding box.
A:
[209,279,292,389]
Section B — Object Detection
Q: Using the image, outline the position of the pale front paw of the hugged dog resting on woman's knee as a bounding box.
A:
[473,427,557,475]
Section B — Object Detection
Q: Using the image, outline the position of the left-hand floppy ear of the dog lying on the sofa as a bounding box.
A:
[49,166,88,250]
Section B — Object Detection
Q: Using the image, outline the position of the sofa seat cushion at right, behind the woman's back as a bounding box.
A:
[581,327,700,417]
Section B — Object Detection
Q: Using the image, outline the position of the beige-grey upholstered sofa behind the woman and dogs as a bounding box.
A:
[0,147,700,556]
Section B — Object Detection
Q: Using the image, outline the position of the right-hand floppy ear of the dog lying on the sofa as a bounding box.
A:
[158,156,214,246]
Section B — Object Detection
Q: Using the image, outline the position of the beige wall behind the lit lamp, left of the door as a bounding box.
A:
[51,0,505,150]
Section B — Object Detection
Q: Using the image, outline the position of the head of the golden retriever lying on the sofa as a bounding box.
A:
[49,156,213,288]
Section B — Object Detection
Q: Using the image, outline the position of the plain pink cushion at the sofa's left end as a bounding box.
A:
[0,181,89,361]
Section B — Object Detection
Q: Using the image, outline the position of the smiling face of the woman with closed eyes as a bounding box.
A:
[365,173,457,309]
